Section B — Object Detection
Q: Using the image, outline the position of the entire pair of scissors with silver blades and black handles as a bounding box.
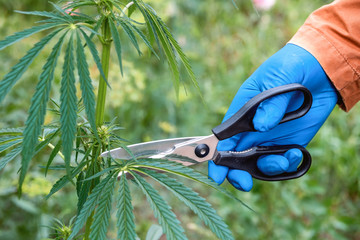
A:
[101,83,312,181]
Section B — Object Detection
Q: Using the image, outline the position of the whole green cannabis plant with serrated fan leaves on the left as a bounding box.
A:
[0,0,245,240]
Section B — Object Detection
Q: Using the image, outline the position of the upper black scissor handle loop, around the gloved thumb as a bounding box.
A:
[212,83,312,140]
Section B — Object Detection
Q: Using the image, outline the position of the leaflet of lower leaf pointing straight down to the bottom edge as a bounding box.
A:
[116,173,136,240]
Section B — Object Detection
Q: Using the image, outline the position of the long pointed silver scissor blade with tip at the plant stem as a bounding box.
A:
[101,137,199,160]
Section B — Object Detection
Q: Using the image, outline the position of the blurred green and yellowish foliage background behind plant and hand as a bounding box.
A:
[0,0,360,240]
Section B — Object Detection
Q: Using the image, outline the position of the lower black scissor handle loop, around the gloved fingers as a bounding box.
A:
[214,145,311,181]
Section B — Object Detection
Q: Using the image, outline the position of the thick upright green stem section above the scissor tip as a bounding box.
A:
[95,16,111,127]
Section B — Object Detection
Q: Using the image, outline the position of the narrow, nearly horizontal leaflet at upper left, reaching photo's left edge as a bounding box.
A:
[0,23,59,50]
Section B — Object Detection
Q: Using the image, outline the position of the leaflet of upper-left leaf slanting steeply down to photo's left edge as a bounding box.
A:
[0,29,61,102]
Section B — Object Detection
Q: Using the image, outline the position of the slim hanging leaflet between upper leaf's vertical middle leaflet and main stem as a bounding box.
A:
[76,31,97,138]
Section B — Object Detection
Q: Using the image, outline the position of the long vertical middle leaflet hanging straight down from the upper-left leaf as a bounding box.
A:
[60,34,78,176]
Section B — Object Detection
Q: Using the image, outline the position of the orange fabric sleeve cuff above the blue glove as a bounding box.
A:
[290,0,360,111]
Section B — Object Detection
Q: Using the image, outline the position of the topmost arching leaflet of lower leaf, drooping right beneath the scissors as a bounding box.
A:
[127,159,253,211]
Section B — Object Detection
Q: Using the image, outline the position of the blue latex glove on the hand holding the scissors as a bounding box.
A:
[209,44,337,191]
